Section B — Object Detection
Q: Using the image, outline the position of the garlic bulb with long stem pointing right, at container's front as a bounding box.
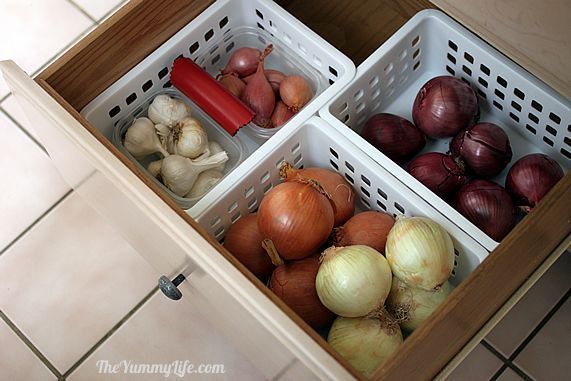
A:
[161,152,228,197]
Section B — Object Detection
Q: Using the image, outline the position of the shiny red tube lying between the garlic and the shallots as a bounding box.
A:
[171,57,255,136]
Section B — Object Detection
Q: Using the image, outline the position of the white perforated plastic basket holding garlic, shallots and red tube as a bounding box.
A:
[81,0,355,211]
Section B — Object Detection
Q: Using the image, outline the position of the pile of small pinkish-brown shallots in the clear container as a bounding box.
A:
[218,44,313,128]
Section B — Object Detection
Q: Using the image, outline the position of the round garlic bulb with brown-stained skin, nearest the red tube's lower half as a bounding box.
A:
[167,117,208,159]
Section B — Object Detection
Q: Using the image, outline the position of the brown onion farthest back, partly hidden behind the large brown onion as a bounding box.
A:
[280,163,355,226]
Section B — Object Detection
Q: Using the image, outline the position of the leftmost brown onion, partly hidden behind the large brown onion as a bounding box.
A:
[224,214,274,280]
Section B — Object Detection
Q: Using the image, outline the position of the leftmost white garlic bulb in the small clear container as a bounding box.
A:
[123,118,169,160]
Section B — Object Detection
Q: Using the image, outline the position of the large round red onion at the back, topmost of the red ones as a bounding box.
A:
[412,76,479,138]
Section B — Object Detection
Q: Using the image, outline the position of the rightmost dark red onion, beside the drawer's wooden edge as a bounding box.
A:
[506,153,564,212]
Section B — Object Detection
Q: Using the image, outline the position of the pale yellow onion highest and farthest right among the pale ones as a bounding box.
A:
[385,217,454,290]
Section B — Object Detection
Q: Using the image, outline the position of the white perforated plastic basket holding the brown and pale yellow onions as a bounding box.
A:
[197,116,488,285]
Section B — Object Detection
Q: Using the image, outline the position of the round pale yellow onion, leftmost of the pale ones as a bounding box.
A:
[315,245,392,317]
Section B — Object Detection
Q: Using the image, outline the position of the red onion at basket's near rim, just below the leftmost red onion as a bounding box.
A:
[407,152,468,199]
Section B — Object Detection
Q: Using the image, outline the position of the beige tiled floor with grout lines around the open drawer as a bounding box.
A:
[0,0,571,381]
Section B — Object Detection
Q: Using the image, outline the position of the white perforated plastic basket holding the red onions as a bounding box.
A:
[319,10,571,251]
